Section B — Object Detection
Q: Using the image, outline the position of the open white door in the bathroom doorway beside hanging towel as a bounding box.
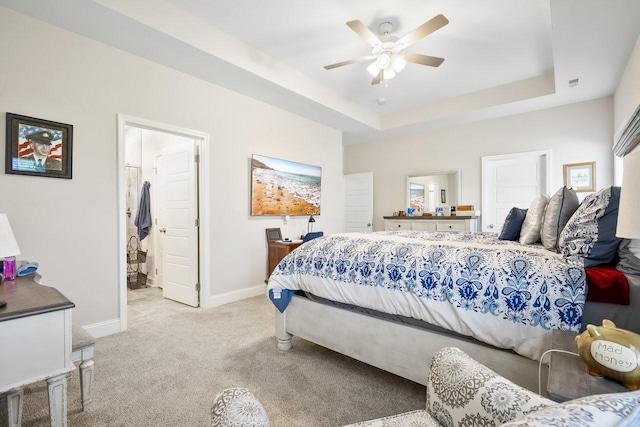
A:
[158,141,199,307]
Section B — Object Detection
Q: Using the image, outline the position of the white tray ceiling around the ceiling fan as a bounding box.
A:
[0,0,640,143]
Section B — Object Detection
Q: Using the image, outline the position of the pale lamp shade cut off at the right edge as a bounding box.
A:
[616,151,640,239]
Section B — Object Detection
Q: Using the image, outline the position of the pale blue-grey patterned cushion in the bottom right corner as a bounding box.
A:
[502,391,640,427]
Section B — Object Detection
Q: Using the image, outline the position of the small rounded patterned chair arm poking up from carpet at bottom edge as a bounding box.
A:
[211,387,271,427]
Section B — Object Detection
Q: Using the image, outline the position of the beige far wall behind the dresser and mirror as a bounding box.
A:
[344,97,613,231]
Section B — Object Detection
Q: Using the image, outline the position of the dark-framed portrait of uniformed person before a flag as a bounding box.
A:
[5,113,73,179]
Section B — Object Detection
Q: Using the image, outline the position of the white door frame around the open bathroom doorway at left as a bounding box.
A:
[117,114,211,332]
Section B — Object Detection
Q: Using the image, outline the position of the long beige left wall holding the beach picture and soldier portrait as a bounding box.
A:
[0,7,344,330]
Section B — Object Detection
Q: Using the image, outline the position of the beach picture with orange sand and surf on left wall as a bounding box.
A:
[251,154,322,216]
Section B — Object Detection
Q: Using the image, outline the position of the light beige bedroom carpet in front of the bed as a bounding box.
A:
[6,290,427,427]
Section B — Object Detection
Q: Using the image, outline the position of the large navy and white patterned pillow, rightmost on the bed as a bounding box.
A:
[558,187,622,267]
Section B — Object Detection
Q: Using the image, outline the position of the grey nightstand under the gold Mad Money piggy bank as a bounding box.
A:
[547,330,630,402]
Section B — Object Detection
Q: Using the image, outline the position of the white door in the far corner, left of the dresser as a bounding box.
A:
[344,172,373,233]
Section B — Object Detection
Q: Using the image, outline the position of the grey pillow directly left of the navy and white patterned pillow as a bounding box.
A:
[540,186,580,252]
